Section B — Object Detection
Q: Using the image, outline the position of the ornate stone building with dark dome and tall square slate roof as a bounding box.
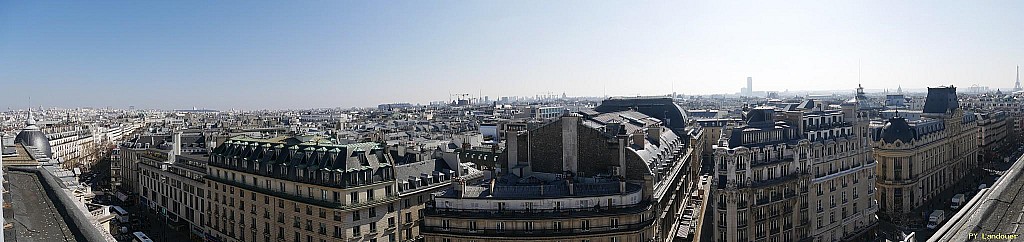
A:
[872,86,979,217]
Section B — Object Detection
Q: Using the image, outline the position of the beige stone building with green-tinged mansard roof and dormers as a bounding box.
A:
[205,136,398,242]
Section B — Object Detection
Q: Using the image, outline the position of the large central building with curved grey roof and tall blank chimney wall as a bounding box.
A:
[421,98,703,242]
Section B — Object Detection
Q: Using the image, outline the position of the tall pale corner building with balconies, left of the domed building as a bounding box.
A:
[709,93,877,241]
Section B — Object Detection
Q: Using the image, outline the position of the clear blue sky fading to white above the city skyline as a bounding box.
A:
[0,0,1024,110]
